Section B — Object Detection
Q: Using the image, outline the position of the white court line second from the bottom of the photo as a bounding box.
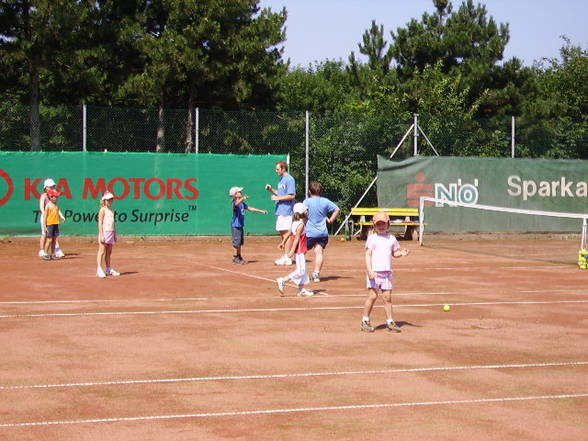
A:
[0,361,588,390]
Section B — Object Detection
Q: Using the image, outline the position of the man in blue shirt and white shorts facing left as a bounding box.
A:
[265,161,296,265]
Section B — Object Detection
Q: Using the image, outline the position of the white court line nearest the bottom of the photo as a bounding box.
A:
[0,393,588,428]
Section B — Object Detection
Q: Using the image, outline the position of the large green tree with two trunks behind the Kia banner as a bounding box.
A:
[120,0,286,151]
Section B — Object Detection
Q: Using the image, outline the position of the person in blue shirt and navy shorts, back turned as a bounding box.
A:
[304,181,340,282]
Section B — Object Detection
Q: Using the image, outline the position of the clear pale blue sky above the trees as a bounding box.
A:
[260,0,588,67]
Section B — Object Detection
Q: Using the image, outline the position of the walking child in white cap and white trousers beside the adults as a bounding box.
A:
[276,202,314,296]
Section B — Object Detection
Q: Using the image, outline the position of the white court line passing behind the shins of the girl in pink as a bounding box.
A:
[0,300,588,319]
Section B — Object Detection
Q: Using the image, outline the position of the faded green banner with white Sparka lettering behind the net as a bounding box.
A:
[377,157,588,233]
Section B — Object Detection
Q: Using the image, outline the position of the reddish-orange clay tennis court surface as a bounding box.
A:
[0,236,588,441]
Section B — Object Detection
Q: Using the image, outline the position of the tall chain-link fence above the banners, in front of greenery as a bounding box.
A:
[0,106,588,218]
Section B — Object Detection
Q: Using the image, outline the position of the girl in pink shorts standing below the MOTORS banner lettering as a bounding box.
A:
[96,192,120,279]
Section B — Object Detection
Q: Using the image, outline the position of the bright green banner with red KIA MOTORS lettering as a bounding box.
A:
[0,152,287,236]
